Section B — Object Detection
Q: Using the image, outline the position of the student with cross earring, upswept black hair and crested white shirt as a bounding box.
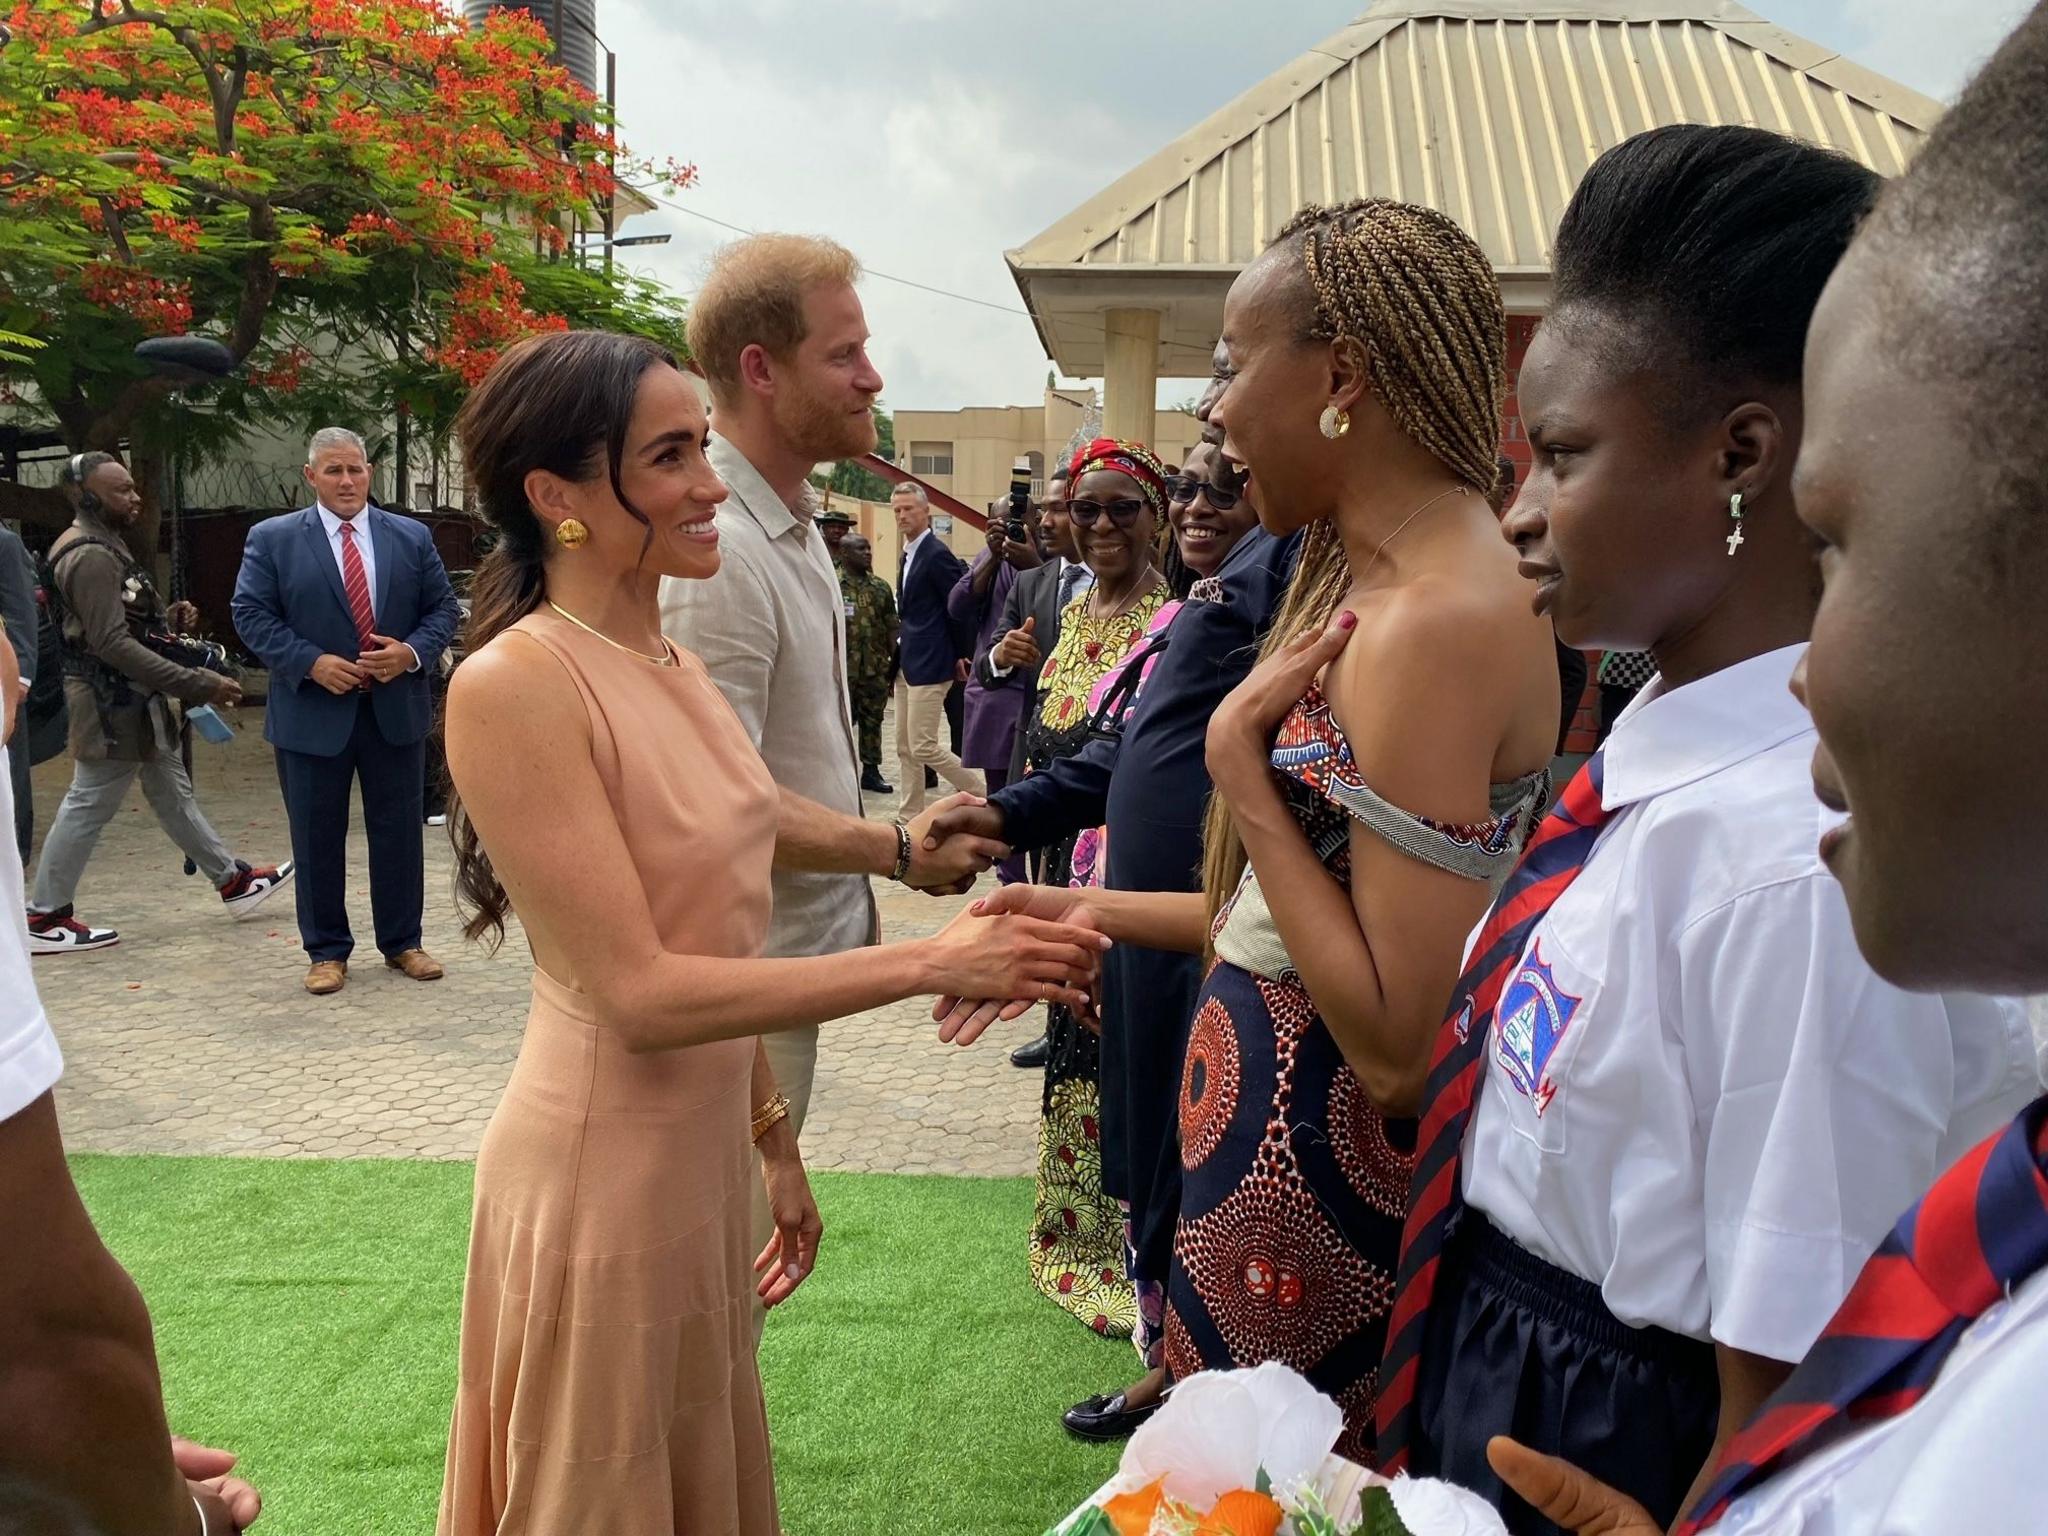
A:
[1380,125,2038,1534]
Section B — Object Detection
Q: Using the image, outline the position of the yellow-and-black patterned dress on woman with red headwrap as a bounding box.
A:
[1024,582,1174,1339]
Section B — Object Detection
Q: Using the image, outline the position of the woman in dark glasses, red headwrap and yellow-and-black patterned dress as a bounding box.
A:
[1024,438,1174,1337]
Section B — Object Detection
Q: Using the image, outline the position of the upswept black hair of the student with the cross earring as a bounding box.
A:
[1550,123,1882,416]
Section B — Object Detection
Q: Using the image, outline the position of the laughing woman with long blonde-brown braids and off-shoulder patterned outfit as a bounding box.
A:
[946,201,1556,1460]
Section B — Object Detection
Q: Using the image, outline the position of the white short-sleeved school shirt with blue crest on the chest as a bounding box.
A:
[1464,645,2038,1360]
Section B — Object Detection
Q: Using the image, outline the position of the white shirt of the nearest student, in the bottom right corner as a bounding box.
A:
[1708,1272,2048,1536]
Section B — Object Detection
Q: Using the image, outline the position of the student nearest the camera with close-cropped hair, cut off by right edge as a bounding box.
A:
[1493,6,2048,1536]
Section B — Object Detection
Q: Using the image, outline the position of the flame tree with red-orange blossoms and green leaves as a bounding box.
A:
[0,0,692,545]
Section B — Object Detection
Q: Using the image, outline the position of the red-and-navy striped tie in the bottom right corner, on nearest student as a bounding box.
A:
[1677,1098,2048,1536]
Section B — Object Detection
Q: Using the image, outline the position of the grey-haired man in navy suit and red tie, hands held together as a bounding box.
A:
[233,426,461,995]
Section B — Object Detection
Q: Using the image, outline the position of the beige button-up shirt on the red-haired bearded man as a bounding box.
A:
[662,436,874,954]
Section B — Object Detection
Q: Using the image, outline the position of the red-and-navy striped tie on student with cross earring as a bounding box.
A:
[1372,752,1610,1477]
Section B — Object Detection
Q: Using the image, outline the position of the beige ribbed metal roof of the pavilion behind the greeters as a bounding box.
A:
[1008,0,1942,379]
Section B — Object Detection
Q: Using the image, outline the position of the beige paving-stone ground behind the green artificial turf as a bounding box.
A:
[35,711,1038,1176]
